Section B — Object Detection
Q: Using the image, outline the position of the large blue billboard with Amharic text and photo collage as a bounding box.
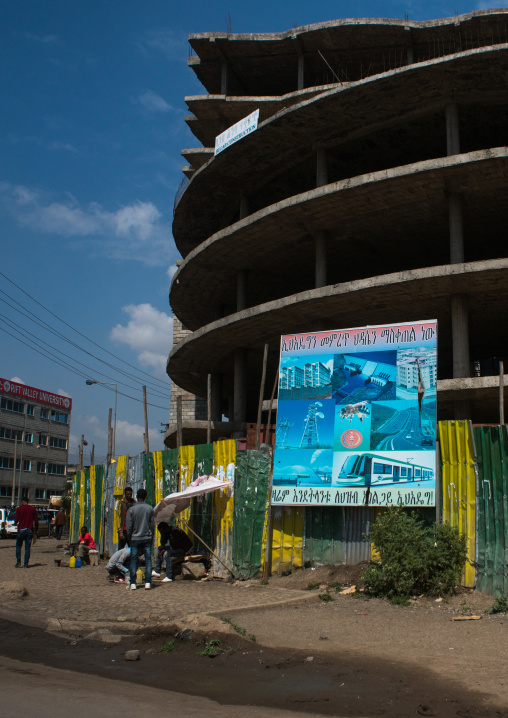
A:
[272,320,437,506]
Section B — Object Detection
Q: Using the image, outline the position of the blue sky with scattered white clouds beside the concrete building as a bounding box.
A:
[0,0,491,460]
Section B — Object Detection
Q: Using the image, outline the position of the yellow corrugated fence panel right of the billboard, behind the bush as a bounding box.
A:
[439,421,476,587]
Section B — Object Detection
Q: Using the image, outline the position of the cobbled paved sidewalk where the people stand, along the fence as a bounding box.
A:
[0,538,313,628]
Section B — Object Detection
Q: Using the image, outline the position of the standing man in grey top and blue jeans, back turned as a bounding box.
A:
[126,489,155,591]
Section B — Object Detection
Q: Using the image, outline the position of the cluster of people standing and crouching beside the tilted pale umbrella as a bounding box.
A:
[106,486,192,591]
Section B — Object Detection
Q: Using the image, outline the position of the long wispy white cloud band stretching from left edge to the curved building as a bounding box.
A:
[0,183,176,265]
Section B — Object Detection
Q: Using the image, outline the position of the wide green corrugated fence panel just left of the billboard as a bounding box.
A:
[233,451,270,579]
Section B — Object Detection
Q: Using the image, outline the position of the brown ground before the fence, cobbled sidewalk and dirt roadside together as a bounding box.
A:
[0,539,508,718]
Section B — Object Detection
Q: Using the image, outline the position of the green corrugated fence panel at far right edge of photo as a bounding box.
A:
[474,426,508,596]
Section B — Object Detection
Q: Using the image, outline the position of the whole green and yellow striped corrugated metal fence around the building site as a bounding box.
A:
[71,421,508,595]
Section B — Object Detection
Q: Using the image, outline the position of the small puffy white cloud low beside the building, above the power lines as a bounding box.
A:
[110,303,173,369]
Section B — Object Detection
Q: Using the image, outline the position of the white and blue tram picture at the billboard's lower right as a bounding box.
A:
[332,452,435,487]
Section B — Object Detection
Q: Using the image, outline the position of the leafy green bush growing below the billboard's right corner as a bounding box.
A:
[363,507,467,600]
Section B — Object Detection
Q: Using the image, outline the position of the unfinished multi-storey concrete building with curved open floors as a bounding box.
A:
[167,10,508,441]
